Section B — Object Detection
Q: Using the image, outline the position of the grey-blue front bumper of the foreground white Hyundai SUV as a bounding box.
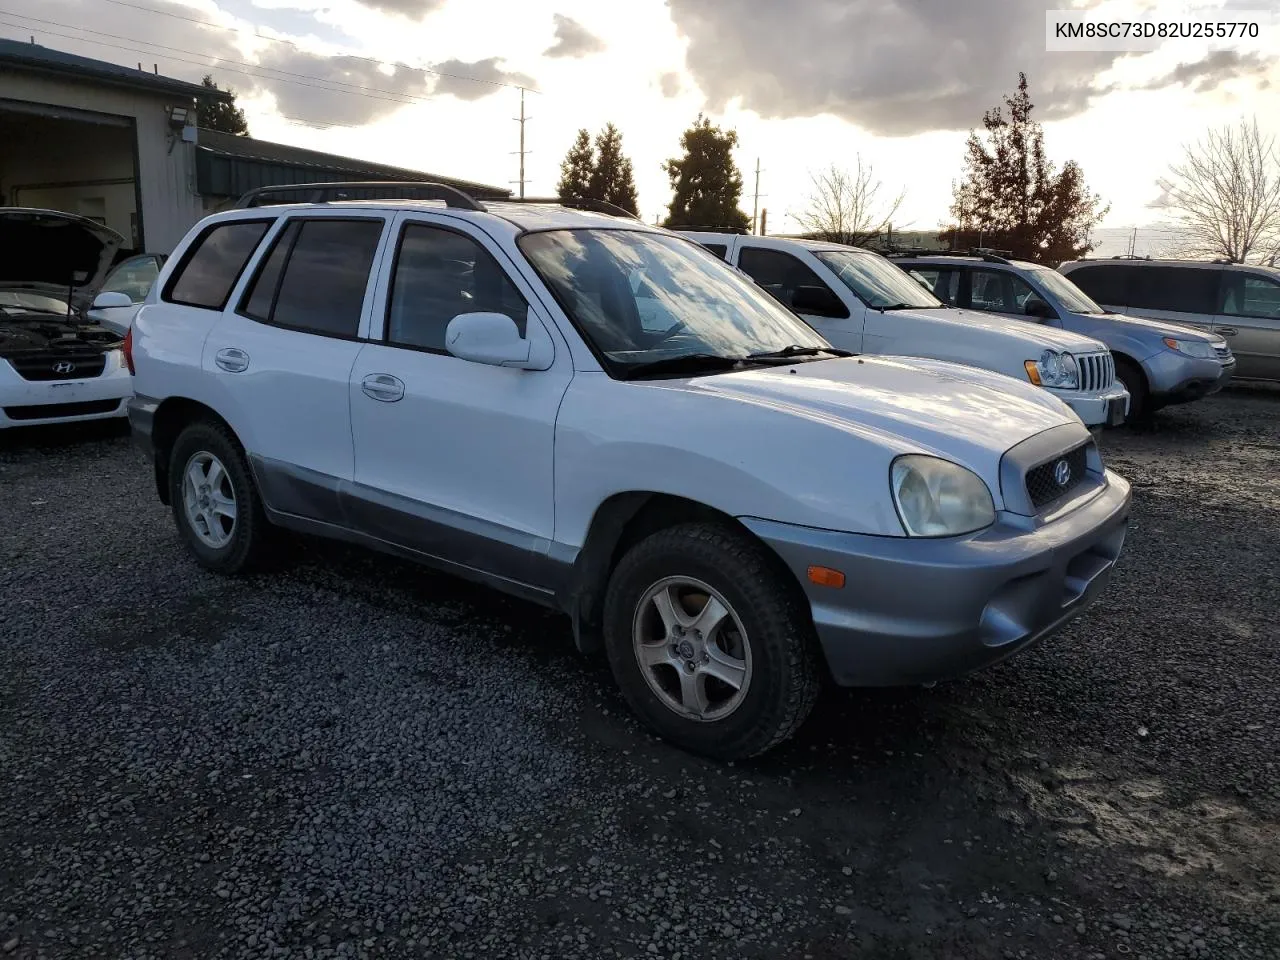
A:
[742,471,1130,686]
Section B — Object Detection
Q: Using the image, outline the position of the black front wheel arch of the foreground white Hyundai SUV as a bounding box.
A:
[564,490,808,654]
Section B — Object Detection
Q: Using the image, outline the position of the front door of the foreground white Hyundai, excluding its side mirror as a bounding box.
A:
[347,214,572,593]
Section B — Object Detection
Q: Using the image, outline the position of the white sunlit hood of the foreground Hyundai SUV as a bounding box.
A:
[652,357,1079,490]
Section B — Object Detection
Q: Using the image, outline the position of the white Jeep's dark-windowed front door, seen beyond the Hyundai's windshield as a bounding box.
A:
[737,245,864,353]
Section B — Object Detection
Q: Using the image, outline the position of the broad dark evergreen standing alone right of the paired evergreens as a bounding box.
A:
[663,114,751,229]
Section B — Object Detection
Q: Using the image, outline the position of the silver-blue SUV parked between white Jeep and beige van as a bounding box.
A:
[893,252,1235,419]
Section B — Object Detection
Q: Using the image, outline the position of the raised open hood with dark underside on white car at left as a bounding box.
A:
[0,206,124,310]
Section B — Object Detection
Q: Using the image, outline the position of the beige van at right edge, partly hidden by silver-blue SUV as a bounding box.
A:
[1057,257,1280,380]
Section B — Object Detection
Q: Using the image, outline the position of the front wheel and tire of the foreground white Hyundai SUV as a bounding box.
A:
[604,524,819,760]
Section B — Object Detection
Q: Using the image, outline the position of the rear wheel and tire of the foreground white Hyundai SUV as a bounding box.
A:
[169,420,269,573]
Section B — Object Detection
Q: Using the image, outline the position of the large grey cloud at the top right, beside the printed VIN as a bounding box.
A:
[668,0,1274,136]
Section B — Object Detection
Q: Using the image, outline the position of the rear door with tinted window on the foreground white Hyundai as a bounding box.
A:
[204,210,387,522]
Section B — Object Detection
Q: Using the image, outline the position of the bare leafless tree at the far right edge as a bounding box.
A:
[1157,118,1280,264]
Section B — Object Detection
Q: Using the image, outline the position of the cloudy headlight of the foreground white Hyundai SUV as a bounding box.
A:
[890,453,996,536]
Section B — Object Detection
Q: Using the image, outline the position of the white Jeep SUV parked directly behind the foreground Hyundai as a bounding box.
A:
[684,232,1129,428]
